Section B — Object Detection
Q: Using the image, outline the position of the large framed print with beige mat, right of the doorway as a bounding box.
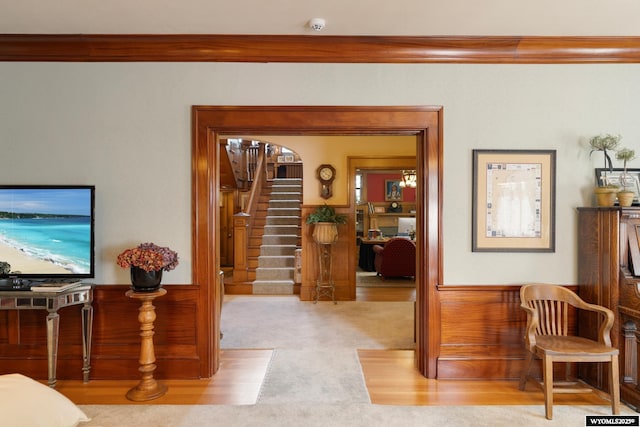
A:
[472,150,556,252]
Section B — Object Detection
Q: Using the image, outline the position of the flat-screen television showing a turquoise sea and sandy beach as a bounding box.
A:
[0,185,95,280]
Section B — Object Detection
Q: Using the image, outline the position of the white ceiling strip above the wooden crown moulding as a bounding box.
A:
[0,0,640,36]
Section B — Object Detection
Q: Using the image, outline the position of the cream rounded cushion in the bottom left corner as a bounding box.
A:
[0,374,90,427]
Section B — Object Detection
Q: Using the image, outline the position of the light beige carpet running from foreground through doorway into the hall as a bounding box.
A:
[80,296,637,427]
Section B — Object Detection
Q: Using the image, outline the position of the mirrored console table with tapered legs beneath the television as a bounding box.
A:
[0,285,93,388]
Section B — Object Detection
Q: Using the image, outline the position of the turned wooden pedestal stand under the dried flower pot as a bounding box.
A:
[126,288,167,402]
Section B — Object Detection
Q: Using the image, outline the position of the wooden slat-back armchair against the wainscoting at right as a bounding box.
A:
[520,284,620,420]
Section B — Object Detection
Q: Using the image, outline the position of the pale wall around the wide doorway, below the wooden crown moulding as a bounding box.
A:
[0,63,640,285]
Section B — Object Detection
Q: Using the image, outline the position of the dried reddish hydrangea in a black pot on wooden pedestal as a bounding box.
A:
[117,243,178,292]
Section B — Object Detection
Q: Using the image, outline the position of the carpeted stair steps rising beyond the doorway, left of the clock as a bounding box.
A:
[253,178,302,294]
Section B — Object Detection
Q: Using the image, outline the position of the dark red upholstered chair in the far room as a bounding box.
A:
[373,238,416,279]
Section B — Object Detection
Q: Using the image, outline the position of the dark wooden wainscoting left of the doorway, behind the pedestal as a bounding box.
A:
[0,285,200,380]
